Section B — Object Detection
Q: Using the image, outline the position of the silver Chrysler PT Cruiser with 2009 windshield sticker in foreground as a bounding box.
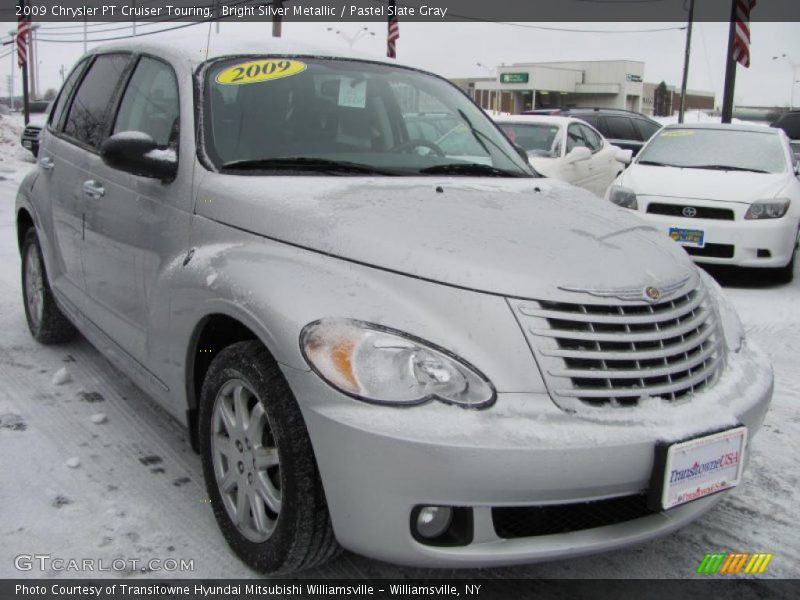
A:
[16,39,772,573]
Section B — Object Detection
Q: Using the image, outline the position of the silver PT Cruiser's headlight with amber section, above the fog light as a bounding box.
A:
[300,320,495,408]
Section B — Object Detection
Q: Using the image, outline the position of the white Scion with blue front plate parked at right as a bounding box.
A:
[608,124,800,282]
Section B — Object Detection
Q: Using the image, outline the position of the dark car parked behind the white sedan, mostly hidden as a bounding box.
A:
[522,108,661,156]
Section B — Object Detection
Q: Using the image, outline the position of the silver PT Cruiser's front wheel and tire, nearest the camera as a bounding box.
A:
[199,341,339,574]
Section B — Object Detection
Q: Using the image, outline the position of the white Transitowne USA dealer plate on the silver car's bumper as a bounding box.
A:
[654,427,747,510]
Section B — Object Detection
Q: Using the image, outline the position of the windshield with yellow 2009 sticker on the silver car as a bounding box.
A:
[203,57,532,177]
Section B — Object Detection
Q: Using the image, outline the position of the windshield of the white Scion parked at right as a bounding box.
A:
[636,128,786,173]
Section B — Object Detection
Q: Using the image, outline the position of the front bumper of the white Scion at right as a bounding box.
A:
[638,197,798,267]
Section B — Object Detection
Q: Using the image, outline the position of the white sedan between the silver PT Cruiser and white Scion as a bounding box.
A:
[495,116,631,196]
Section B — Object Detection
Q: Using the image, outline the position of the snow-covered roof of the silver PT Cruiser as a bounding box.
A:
[88,36,408,66]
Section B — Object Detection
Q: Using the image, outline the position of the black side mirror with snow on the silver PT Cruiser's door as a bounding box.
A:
[100,131,178,181]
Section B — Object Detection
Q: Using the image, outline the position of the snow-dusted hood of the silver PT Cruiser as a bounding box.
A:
[196,173,692,298]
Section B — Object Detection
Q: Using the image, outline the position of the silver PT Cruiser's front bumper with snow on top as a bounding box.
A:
[284,346,772,567]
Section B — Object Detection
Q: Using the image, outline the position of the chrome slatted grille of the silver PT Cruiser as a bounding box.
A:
[511,284,724,409]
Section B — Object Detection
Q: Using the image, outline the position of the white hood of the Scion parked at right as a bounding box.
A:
[620,164,787,204]
